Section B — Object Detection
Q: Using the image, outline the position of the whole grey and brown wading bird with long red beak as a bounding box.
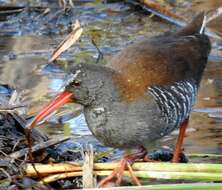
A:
[27,12,211,187]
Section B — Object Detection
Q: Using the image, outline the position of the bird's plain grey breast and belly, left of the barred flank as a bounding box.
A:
[84,98,175,148]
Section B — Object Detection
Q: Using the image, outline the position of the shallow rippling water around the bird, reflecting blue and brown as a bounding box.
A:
[0,1,222,159]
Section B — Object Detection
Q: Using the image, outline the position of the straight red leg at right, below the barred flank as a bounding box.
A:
[172,118,189,163]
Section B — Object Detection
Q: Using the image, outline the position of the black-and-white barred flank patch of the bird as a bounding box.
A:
[148,81,197,132]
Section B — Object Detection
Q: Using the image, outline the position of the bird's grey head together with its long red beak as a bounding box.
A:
[28,64,114,129]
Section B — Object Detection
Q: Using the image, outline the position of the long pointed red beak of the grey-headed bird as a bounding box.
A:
[28,91,73,129]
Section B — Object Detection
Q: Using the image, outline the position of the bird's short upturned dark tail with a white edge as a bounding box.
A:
[176,12,206,36]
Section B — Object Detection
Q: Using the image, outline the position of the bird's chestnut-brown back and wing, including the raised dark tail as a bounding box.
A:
[108,13,210,100]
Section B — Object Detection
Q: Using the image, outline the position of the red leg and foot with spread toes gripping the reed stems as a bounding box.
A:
[98,147,147,187]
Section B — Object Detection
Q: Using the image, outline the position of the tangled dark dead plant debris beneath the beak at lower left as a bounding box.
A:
[0,87,81,189]
